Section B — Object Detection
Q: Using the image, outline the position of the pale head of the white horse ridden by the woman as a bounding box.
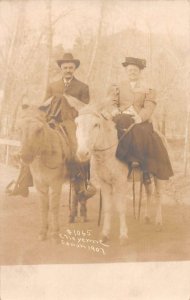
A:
[75,105,116,161]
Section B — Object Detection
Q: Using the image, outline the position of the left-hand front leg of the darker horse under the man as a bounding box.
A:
[34,182,49,240]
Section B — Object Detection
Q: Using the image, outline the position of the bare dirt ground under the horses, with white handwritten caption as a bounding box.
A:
[0,146,190,265]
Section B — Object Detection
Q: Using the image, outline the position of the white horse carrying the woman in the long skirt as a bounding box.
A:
[75,105,162,244]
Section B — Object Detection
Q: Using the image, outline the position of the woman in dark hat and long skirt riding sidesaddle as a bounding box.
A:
[109,57,173,184]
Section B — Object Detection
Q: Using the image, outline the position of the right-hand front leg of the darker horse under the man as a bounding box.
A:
[50,180,62,239]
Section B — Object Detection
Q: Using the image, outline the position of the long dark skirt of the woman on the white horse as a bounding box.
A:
[114,114,173,180]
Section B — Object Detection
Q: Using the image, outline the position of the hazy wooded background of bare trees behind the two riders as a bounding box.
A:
[0,0,190,172]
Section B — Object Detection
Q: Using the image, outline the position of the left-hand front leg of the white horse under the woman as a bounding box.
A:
[101,182,112,242]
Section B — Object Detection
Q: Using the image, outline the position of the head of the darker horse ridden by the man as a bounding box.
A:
[19,105,45,163]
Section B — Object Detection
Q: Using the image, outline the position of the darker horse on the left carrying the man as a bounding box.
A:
[20,106,69,240]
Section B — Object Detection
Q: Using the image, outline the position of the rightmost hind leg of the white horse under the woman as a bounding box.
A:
[154,178,164,231]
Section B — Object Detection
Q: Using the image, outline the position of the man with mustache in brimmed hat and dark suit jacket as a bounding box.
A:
[44,53,90,158]
